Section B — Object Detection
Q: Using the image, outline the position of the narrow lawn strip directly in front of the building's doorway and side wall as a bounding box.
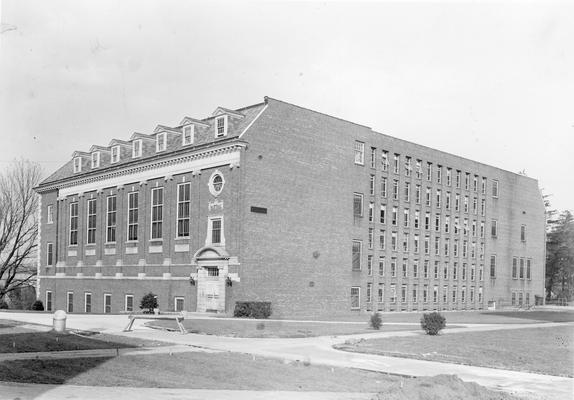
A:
[147,318,418,338]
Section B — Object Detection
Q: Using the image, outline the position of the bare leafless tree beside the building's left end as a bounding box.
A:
[0,160,41,300]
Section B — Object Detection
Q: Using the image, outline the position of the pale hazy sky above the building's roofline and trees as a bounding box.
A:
[0,0,574,210]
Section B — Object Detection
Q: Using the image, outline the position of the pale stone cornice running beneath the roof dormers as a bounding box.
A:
[36,140,247,193]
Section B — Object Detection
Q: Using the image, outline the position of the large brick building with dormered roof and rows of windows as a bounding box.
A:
[37,98,545,316]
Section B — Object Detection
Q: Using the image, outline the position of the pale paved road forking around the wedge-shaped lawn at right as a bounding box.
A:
[0,313,574,400]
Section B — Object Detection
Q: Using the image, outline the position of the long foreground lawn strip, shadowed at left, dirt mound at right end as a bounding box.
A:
[0,352,516,400]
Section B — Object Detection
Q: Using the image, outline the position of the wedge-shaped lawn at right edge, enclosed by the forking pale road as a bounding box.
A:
[336,326,574,377]
